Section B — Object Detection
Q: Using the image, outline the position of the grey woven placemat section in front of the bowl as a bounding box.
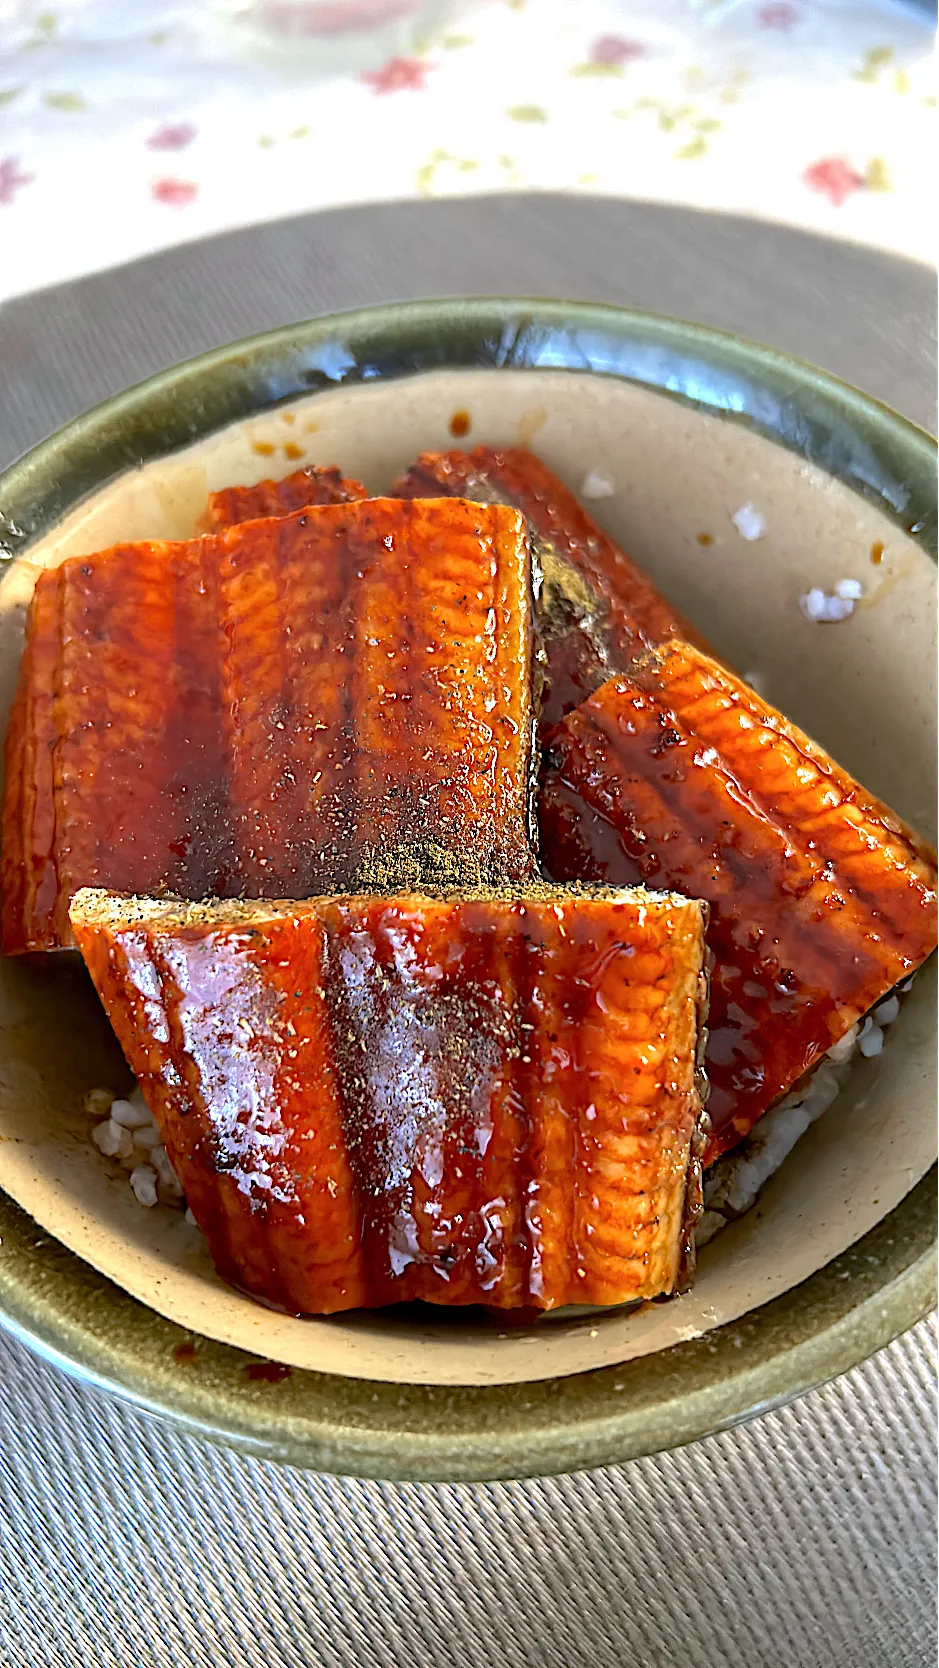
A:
[0,1323,936,1668]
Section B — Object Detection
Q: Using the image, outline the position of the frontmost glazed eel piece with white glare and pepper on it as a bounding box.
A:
[72,886,706,1314]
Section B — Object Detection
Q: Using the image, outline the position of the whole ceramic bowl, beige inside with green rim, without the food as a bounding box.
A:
[0,300,936,1480]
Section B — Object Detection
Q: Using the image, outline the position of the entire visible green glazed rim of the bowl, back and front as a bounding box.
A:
[0,299,936,1481]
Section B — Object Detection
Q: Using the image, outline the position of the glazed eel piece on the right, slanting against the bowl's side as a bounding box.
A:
[540,642,936,1159]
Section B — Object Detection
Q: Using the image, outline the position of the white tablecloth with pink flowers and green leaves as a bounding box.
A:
[0,0,936,299]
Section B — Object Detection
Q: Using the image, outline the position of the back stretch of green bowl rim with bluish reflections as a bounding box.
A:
[0,297,939,562]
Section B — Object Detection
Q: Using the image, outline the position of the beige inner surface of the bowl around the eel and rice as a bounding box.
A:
[0,370,936,1384]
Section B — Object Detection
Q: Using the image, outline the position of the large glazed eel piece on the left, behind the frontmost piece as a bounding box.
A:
[2,499,534,954]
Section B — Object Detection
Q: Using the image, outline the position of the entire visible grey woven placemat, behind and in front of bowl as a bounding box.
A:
[0,197,936,1668]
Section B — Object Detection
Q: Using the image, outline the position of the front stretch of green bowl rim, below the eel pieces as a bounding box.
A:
[0,1166,937,1483]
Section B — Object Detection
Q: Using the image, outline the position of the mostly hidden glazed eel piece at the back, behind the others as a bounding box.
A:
[394,445,707,729]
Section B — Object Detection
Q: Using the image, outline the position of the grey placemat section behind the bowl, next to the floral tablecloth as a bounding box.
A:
[0,193,936,469]
